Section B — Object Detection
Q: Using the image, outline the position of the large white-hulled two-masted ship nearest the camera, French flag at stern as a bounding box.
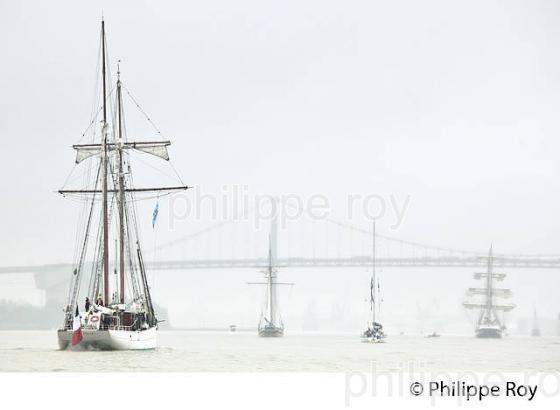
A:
[57,21,188,350]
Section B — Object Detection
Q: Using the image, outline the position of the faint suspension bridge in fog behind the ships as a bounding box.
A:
[0,215,560,308]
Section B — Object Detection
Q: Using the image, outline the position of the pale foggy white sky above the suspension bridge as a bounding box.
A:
[0,0,560,330]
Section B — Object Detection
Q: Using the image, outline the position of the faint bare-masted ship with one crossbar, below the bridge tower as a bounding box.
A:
[250,235,293,337]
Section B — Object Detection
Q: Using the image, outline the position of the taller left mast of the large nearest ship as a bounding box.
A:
[101,20,109,304]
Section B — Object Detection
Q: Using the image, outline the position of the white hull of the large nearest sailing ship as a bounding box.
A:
[58,327,157,350]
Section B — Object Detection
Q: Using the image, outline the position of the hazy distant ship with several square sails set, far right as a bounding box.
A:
[463,246,515,339]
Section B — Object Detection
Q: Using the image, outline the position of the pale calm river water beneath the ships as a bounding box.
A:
[0,331,560,372]
